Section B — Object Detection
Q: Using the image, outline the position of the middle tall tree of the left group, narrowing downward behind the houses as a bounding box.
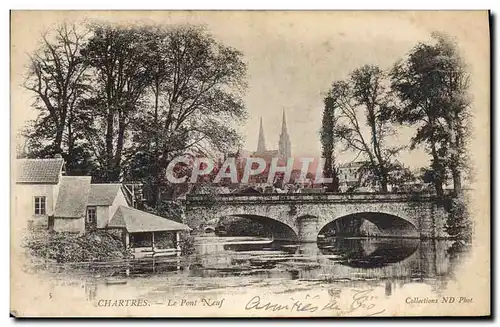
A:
[82,24,151,181]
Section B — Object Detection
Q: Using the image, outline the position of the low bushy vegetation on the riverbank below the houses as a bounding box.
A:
[24,231,129,263]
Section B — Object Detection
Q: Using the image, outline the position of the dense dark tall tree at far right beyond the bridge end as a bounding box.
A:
[390,34,470,196]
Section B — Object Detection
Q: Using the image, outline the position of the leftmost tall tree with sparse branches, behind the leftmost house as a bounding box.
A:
[24,23,89,173]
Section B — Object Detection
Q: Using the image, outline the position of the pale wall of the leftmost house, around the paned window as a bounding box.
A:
[13,184,59,228]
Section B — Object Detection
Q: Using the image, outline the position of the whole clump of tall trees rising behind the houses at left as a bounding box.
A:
[25,22,246,206]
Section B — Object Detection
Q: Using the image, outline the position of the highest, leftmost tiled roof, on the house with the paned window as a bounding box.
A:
[16,158,64,184]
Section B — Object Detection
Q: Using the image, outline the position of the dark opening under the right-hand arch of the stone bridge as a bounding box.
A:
[318,211,420,237]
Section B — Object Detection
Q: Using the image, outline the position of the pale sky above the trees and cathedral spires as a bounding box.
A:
[11,11,489,172]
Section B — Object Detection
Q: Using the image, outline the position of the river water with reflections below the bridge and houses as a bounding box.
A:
[36,236,467,310]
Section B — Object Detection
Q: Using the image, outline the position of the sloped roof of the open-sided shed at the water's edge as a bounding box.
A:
[108,206,190,233]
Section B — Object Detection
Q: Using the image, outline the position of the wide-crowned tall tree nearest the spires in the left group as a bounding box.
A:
[125,26,246,205]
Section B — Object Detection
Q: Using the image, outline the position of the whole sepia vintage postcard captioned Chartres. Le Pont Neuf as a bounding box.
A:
[10,11,491,317]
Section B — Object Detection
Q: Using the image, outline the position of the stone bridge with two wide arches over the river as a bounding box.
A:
[186,193,447,242]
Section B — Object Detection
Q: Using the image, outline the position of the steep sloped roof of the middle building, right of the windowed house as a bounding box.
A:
[54,176,91,218]
